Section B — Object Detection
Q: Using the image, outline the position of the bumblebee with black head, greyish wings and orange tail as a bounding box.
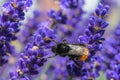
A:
[52,40,89,61]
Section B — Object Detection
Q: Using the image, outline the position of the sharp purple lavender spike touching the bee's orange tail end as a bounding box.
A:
[67,4,109,80]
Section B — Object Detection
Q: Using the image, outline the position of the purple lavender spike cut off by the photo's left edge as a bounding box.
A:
[0,0,32,65]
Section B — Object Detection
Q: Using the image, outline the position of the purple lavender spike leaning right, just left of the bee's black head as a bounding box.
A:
[10,23,55,80]
